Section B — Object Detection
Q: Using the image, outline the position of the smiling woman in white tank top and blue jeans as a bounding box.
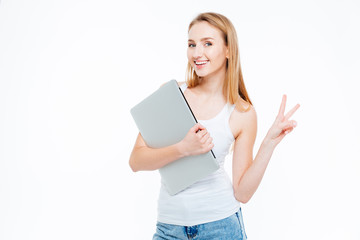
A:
[129,13,299,240]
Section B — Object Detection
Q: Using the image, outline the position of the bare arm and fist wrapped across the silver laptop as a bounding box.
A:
[129,124,214,172]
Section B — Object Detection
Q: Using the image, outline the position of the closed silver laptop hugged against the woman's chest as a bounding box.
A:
[130,80,219,195]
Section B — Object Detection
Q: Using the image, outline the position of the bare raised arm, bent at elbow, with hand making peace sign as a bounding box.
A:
[233,95,300,203]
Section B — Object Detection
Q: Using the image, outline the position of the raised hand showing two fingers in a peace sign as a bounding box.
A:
[265,95,300,146]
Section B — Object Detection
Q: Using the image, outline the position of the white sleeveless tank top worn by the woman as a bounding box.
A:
[158,83,240,226]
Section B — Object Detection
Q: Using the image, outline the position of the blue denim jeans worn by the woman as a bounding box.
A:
[153,208,247,240]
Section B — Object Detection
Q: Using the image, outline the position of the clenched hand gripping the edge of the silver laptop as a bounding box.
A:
[179,123,214,156]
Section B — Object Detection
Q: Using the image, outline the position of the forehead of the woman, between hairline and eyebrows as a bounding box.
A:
[189,21,223,41]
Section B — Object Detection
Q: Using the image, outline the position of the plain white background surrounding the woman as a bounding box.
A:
[0,0,360,240]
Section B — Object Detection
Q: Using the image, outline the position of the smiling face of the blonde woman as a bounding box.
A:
[187,21,228,77]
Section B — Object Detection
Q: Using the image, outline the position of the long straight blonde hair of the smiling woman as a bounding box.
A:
[186,12,252,111]
